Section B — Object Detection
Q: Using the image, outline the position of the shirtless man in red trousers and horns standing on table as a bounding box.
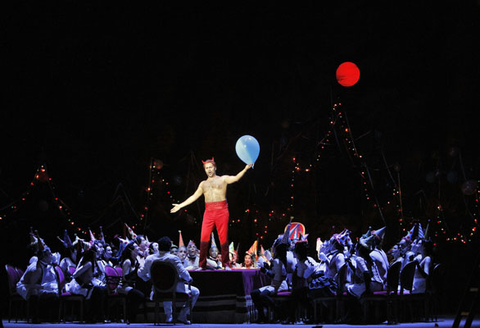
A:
[170,158,253,269]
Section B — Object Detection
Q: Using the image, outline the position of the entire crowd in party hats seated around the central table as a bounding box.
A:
[17,219,433,324]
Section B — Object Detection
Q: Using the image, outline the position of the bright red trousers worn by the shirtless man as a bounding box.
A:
[198,200,230,268]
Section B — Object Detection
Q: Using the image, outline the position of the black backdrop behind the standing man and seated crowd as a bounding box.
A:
[0,0,480,316]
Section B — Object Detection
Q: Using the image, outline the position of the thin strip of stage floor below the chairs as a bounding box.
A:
[3,317,480,328]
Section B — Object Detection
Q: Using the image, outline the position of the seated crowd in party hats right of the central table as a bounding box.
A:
[252,223,434,324]
